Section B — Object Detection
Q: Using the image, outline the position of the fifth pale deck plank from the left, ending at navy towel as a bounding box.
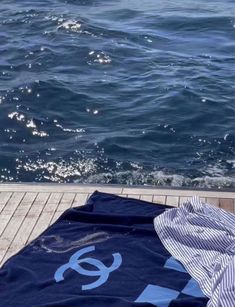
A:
[28,192,63,242]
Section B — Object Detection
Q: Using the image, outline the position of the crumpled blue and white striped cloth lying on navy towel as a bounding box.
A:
[154,197,235,307]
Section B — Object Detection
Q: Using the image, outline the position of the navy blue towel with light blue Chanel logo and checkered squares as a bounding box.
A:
[0,192,208,307]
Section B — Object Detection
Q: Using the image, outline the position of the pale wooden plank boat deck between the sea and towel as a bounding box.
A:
[0,183,235,267]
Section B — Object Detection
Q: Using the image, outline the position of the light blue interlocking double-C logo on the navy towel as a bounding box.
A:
[54,246,122,290]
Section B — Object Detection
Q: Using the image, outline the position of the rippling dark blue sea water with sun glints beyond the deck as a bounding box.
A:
[0,0,235,188]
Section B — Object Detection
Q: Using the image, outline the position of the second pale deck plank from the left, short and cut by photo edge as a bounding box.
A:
[0,192,25,236]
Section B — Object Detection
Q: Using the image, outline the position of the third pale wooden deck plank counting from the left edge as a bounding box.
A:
[0,193,37,262]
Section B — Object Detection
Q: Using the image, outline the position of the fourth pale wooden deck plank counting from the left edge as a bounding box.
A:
[0,193,50,265]
